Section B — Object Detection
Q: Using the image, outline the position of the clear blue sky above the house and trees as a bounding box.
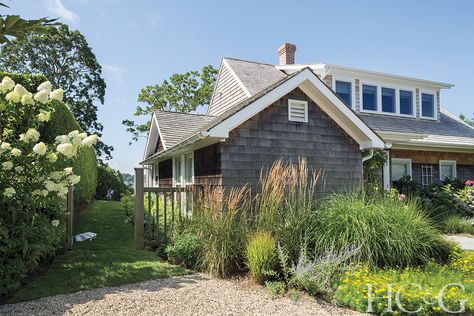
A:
[3,0,474,173]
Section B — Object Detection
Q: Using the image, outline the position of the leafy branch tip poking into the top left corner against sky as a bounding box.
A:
[0,2,56,44]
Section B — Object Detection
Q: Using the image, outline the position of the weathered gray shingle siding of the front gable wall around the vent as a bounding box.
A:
[217,89,362,193]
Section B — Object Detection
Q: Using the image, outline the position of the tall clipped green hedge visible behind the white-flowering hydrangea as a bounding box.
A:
[0,71,97,205]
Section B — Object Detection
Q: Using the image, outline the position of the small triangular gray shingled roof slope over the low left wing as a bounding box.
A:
[155,111,215,148]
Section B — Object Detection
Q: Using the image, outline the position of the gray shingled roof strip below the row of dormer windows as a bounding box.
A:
[357,110,474,138]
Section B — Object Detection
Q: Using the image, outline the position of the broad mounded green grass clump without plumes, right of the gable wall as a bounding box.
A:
[316,193,451,267]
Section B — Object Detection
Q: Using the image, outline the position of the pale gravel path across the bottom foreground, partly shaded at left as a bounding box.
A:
[0,274,357,316]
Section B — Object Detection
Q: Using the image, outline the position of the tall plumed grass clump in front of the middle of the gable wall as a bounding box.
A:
[255,159,321,260]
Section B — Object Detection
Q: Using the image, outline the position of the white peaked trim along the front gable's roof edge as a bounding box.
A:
[209,69,385,149]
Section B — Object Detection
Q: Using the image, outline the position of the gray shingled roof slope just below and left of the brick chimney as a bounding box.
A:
[224,57,286,95]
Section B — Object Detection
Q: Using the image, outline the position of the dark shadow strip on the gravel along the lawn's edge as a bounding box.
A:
[0,274,210,316]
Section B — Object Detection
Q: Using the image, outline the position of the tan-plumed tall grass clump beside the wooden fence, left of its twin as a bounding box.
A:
[189,187,250,277]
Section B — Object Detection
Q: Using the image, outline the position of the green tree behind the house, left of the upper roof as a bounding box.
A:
[122,65,218,143]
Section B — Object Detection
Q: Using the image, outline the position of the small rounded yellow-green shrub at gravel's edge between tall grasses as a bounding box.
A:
[245,232,277,284]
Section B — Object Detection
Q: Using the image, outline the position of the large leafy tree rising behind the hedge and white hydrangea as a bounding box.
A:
[0,23,113,159]
